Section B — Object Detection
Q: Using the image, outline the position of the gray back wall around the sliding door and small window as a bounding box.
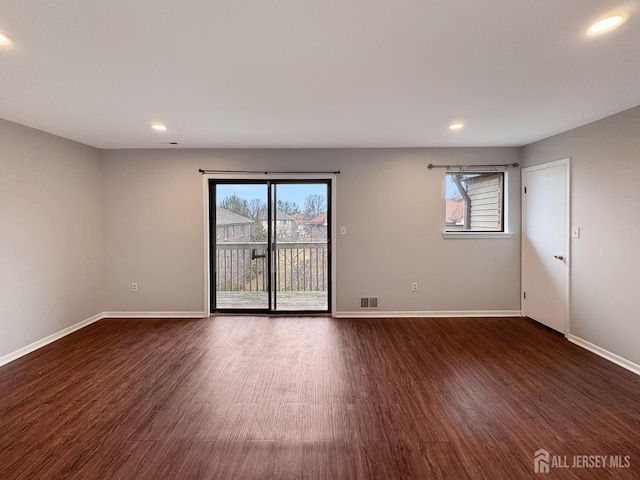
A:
[102,148,520,312]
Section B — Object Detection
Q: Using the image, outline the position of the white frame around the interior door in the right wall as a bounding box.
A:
[520,157,572,337]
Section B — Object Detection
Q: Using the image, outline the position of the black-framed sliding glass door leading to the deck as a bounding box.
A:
[209,180,331,313]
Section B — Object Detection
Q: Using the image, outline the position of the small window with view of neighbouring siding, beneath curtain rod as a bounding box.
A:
[445,172,505,232]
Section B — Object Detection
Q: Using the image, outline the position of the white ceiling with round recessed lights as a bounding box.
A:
[0,0,640,148]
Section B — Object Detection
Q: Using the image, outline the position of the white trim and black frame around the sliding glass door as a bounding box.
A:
[202,173,337,317]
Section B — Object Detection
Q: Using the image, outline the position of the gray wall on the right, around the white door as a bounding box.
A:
[522,107,640,364]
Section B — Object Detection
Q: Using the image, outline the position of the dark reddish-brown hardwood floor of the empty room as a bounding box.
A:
[0,316,640,480]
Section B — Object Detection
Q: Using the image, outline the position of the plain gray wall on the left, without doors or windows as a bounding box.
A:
[0,120,104,357]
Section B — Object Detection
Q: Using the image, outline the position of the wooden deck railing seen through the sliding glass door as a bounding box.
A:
[215,242,329,292]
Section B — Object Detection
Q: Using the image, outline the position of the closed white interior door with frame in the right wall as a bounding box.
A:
[522,159,569,333]
